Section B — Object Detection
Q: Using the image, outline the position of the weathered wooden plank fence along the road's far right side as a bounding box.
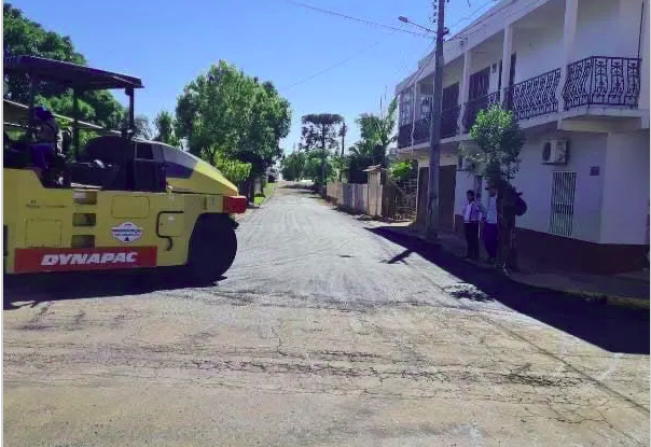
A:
[326,183,386,217]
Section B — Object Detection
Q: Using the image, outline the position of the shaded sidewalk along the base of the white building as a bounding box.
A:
[373,222,649,309]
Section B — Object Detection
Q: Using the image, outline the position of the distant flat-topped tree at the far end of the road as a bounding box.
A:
[300,113,344,186]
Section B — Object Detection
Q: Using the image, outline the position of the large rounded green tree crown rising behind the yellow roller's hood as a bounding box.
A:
[174,61,291,175]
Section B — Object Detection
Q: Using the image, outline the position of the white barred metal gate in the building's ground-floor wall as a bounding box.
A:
[549,171,576,237]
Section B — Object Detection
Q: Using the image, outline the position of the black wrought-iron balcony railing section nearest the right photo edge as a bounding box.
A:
[563,56,640,110]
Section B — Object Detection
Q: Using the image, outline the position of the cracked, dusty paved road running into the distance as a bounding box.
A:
[3,183,650,447]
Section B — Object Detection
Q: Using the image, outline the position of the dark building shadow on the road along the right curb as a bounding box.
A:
[368,227,649,354]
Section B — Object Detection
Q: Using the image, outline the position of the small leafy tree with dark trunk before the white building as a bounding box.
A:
[462,105,526,270]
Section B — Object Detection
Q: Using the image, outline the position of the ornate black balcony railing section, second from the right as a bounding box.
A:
[502,68,561,121]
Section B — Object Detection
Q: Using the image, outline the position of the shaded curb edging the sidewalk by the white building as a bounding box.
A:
[380,228,650,310]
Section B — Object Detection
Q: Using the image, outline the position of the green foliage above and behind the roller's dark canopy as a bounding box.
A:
[3,3,125,129]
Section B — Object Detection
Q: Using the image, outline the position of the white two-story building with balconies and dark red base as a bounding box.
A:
[396,0,651,273]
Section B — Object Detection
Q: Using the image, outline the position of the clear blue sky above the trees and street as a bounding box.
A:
[10,0,495,152]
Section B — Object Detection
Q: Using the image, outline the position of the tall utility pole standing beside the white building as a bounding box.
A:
[425,0,446,241]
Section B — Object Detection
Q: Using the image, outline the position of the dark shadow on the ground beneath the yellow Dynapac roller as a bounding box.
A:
[3,267,225,310]
